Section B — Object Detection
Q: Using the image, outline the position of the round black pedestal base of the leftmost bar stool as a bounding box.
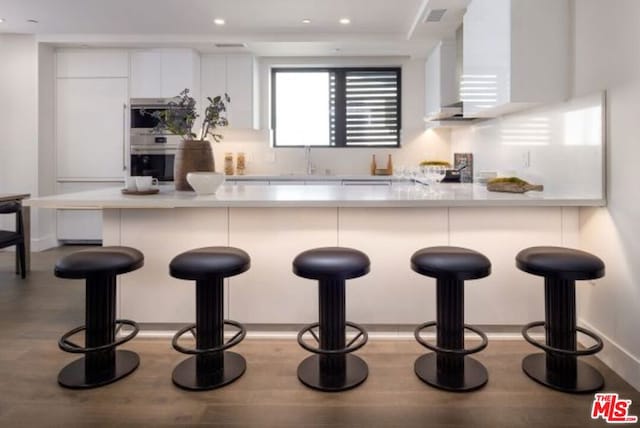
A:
[58,351,140,389]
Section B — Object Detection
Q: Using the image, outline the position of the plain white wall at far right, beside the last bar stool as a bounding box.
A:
[573,0,640,389]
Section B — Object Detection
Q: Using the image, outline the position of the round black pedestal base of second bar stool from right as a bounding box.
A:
[414,352,489,392]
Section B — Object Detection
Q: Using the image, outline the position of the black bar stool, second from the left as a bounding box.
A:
[169,247,251,391]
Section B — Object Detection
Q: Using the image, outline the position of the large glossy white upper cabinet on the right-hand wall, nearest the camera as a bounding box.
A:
[460,0,570,117]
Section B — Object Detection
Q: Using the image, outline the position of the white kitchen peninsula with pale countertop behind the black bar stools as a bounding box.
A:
[27,183,604,329]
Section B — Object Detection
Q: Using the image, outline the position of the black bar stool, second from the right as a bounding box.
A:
[411,247,491,392]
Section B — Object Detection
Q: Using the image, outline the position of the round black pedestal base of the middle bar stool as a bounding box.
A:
[298,354,369,392]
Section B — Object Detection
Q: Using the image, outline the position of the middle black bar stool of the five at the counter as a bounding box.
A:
[293,247,370,392]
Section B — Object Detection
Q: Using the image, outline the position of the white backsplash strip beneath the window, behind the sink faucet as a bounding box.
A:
[213,129,451,175]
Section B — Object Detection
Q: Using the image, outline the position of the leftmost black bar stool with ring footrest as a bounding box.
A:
[54,247,144,389]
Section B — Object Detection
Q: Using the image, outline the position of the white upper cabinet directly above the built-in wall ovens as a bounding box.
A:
[131,49,200,99]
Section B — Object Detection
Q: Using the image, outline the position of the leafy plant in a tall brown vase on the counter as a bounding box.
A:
[149,89,231,190]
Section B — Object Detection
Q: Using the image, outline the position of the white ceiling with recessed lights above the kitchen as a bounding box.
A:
[0,0,470,56]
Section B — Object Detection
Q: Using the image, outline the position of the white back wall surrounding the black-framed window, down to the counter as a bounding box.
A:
[208,57,450,174]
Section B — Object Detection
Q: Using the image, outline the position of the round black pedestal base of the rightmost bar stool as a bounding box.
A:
[522,354,604,393]
